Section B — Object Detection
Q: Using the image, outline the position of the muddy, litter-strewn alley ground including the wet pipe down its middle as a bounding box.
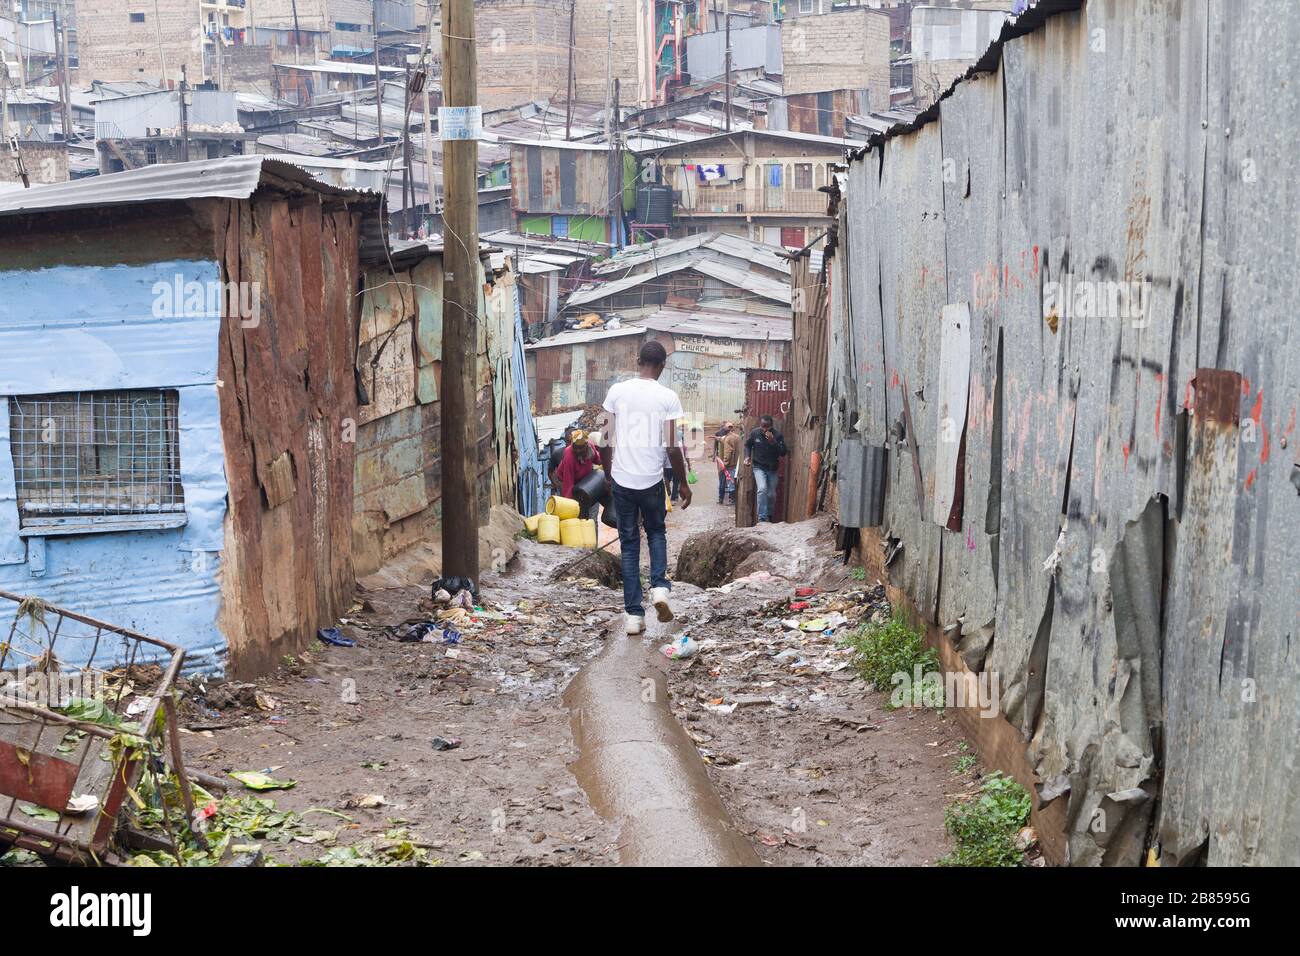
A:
[172,493,974,866]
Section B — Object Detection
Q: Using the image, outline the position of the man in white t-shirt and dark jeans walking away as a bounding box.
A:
[605,341,690,633]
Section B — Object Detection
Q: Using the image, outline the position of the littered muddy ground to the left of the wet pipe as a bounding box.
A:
[185,542,618,865]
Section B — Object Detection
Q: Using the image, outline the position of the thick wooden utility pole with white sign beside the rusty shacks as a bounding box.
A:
[438,0,480,580]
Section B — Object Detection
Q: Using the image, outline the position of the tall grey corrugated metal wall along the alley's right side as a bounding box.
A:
[831,0,1300,865]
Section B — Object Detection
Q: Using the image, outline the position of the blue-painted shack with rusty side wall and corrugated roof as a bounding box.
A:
[0,156,380,676]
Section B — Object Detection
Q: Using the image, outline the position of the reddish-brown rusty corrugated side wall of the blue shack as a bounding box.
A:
[211,194,361,676]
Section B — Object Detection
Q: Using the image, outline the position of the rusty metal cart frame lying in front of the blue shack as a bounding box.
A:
[0,591,202,864]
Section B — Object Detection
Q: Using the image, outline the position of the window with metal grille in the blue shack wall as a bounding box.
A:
[9,389,185,525]
